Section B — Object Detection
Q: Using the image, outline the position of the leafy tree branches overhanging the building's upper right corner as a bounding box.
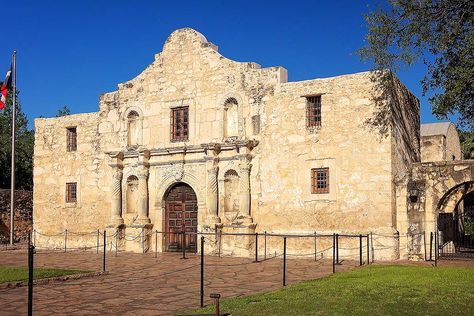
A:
[359,0,474,127]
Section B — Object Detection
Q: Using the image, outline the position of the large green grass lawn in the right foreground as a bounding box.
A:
[184,266,474,316]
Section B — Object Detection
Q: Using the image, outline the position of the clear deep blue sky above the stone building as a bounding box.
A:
[0,0,448,128]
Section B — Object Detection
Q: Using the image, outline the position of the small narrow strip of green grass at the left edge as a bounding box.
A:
[0,267,87,283]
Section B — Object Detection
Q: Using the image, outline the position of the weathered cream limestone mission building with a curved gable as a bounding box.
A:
[34,29,420,259]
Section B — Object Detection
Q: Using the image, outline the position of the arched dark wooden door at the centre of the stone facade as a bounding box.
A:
[165,183,198,252]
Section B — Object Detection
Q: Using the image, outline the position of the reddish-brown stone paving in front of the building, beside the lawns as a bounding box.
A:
[0,250,356,315]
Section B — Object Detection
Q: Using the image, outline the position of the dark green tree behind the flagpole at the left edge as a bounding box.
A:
[0,91,34,190]
